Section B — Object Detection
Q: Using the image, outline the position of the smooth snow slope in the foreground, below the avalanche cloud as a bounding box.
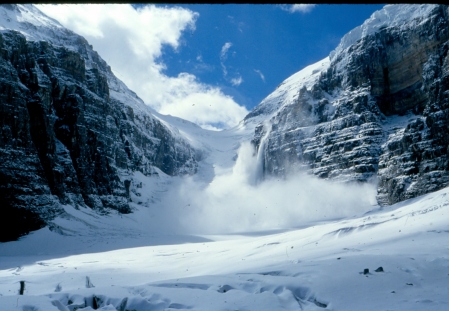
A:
[0,189,449,311]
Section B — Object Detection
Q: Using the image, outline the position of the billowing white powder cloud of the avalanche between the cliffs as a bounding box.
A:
[156,142,376,234]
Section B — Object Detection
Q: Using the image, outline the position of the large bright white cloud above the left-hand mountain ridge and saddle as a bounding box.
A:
[37,4,248,128]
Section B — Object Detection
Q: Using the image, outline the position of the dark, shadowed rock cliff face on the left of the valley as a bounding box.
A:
[0,6,198,241]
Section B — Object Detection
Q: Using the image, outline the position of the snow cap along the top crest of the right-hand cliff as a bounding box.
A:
[329,4,437,60]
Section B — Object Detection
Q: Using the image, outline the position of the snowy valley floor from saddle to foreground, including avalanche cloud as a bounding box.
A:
[0,120,449,311]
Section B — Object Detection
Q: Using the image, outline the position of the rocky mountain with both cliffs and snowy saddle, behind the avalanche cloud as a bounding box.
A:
[0,5,449,240]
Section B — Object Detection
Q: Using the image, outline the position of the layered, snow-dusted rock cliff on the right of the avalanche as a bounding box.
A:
[246,5,449,204]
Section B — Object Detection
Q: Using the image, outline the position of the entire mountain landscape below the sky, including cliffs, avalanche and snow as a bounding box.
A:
[0,5,449,311]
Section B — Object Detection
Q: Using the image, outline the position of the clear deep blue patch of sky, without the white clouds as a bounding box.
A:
[154,4,383,110]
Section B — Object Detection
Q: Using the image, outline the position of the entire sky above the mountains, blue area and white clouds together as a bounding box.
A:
[37,4,383,130]
